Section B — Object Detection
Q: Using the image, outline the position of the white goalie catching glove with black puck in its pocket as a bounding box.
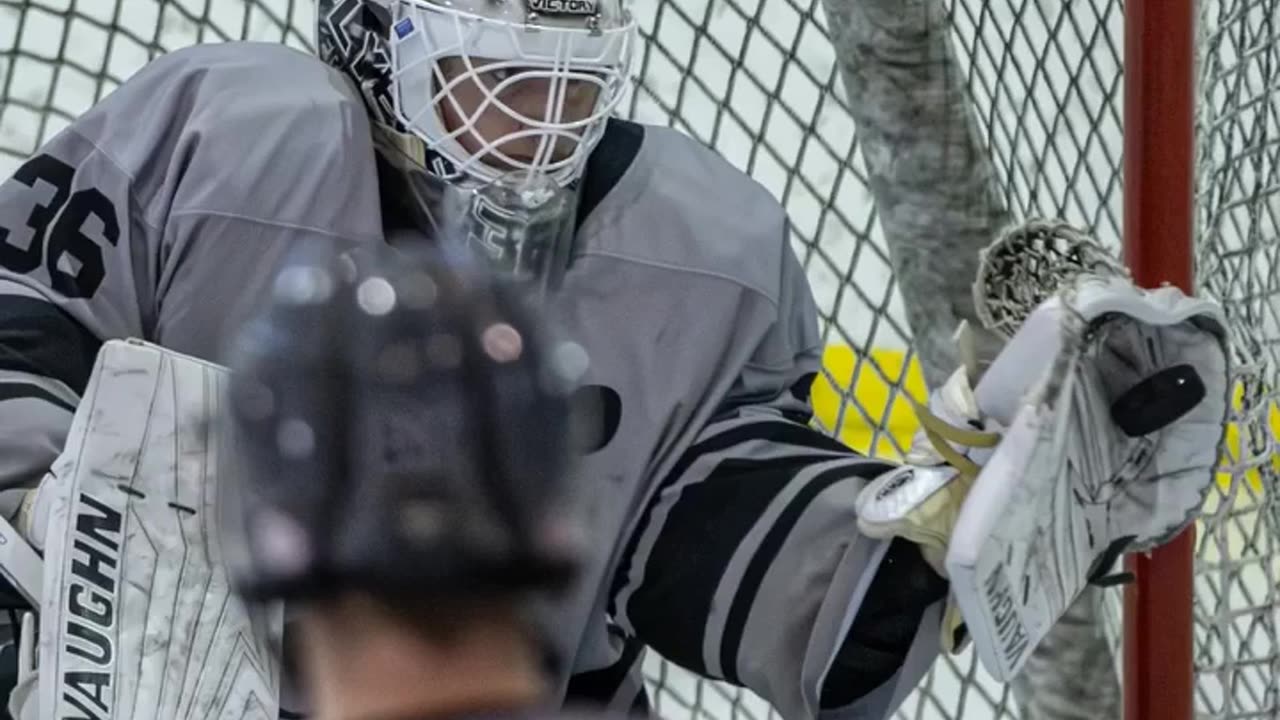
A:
[858,223,1228,680]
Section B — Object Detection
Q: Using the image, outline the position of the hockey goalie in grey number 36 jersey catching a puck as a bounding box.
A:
[0,0,1226,719]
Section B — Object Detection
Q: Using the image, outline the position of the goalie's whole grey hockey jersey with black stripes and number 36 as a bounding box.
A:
[0,44,945,719]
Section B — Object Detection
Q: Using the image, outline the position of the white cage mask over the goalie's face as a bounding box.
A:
[389,0,635,184]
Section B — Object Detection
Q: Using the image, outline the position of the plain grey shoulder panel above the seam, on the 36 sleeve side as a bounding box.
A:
[72,42,374,233]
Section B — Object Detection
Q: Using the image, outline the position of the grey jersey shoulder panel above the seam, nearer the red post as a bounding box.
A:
[580,120,790,302]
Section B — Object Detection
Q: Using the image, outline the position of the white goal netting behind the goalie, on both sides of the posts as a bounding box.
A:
[0,0,1280,720]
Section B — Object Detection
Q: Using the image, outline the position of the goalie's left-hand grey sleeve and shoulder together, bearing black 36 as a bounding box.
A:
[0,44,381,512]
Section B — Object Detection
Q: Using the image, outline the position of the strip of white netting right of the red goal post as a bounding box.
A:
[1194,0,1280,717]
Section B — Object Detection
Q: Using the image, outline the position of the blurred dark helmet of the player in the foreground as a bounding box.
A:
[221,246,584,600]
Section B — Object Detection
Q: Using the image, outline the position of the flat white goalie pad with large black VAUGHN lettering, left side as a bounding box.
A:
[38,341,282,720]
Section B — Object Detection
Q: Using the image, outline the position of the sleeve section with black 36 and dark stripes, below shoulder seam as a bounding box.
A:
[0,131,140,507]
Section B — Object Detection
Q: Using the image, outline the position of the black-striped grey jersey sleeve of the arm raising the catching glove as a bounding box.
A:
[612,235,946,717]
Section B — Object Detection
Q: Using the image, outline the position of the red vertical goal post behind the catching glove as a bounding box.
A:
[1123,0,1196,720]
